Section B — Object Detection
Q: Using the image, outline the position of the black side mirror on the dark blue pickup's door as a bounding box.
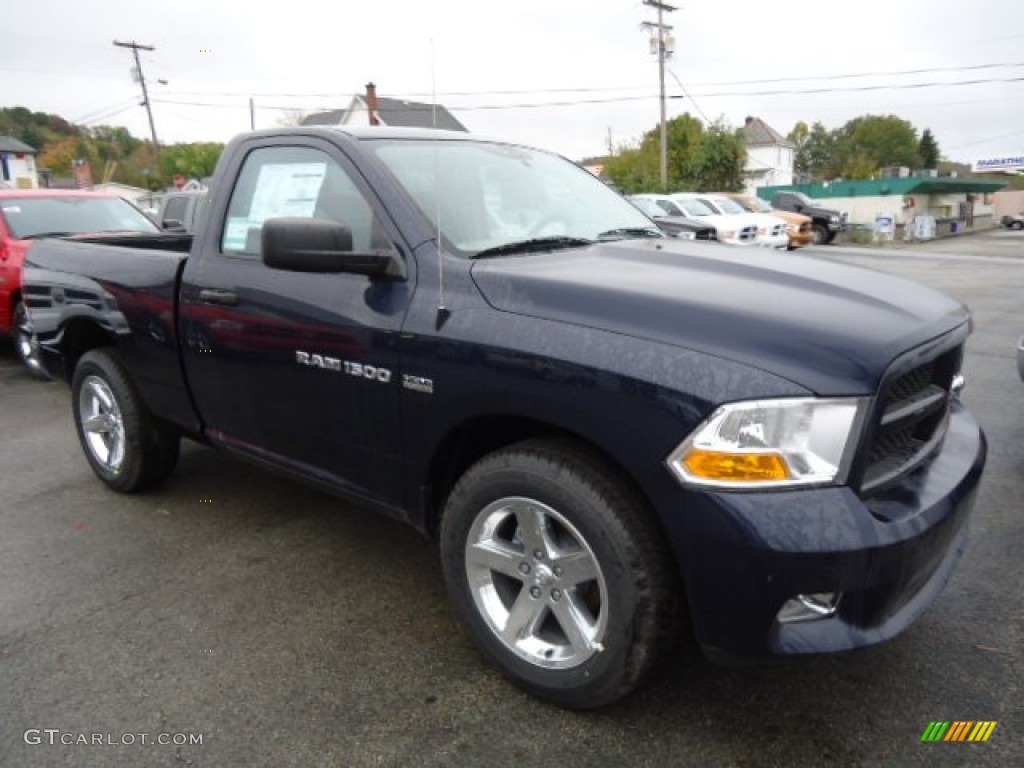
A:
[261,218,406,280]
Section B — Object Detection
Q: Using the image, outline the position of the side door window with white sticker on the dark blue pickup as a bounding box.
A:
[220,146,391,259]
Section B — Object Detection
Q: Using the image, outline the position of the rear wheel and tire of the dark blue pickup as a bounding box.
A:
[72,349,180,494]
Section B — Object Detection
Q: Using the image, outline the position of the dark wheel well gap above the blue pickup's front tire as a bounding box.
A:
[423,416,648,537]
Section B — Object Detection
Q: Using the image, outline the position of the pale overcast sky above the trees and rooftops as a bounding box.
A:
[0,0,1024,162]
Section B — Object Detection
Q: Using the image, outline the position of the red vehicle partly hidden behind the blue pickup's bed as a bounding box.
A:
[0,189,160,370]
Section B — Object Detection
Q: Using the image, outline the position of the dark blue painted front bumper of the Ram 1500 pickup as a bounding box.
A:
[670,402,986,656]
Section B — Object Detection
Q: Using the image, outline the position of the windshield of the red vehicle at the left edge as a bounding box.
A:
[0,196,160,240]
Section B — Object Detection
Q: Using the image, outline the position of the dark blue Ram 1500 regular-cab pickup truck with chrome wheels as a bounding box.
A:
[25,128,986,708]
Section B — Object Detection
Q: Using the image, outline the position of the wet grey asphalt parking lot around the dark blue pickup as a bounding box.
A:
[0,232,1024,767]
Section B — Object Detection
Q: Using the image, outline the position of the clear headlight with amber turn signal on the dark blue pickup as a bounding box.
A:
[667,397,866,488]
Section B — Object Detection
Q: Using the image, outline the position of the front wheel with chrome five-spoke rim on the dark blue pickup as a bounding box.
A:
[441,440,681,709]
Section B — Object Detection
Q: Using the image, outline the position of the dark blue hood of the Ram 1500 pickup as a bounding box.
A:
[472,240,969,395]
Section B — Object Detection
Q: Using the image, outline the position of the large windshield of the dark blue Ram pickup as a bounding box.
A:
[371,140,653,257]
